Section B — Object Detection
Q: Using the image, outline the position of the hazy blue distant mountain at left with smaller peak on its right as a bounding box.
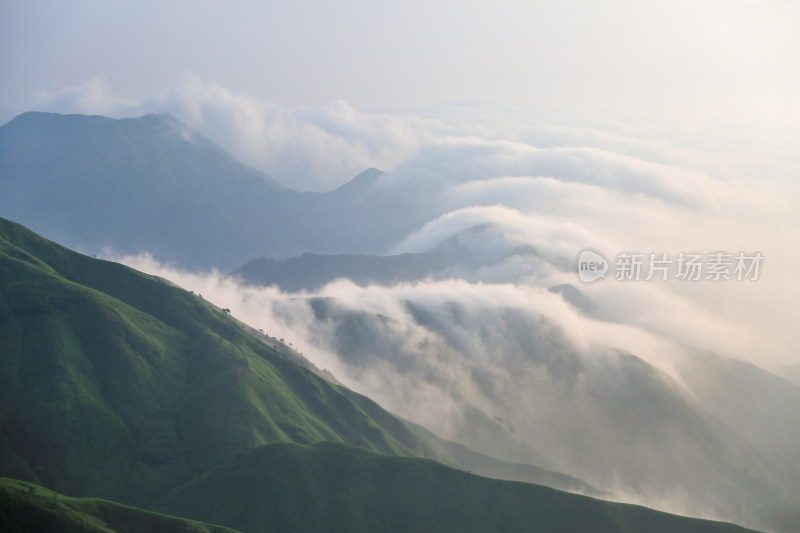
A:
[0,112,427,270]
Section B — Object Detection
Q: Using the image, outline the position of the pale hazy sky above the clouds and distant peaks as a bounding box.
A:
[0,0,800,124]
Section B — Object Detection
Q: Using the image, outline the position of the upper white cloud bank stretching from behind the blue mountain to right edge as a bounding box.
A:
[67,83,800,372]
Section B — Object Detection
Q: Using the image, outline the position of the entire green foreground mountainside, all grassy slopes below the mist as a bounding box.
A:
[0,219,764,531]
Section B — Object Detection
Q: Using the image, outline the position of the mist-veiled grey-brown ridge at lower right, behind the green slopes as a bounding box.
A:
[270,293,800,531]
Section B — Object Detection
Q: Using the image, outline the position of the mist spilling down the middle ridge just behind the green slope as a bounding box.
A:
[114,252,798,526]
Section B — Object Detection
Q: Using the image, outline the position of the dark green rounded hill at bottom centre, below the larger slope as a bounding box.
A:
[157,443,747,533]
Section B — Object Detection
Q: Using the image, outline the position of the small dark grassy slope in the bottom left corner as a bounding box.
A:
[0,478,241,533]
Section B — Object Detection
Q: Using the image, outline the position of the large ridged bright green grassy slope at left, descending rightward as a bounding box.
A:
[0,219,438,506]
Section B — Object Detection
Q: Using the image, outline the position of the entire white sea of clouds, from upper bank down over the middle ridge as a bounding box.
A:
[34,73,800,528]
